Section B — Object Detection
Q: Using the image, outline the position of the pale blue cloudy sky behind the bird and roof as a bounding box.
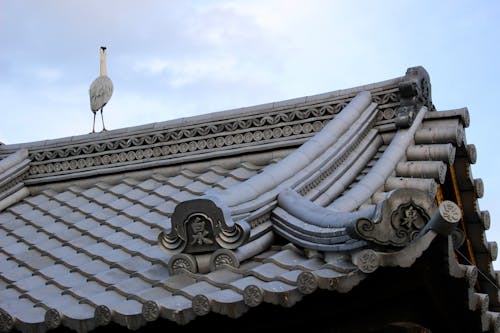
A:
[0,0,500,269]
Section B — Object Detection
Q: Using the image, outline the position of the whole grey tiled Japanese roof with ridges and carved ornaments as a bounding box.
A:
[0,67,500,332]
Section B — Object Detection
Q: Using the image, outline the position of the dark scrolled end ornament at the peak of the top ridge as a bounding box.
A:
[396,66,435,128]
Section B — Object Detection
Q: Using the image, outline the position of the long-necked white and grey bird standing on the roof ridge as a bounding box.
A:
[89,46,113,133]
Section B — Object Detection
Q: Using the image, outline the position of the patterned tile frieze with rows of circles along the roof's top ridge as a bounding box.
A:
[22,88,399,178]
